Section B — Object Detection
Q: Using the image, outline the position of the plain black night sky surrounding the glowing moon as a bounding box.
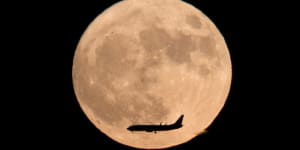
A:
[2,0,294,149]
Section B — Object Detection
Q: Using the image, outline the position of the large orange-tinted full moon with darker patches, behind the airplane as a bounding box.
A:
[72,0,232,149]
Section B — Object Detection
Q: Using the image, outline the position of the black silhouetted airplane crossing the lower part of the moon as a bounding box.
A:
[127,115,184,133]
